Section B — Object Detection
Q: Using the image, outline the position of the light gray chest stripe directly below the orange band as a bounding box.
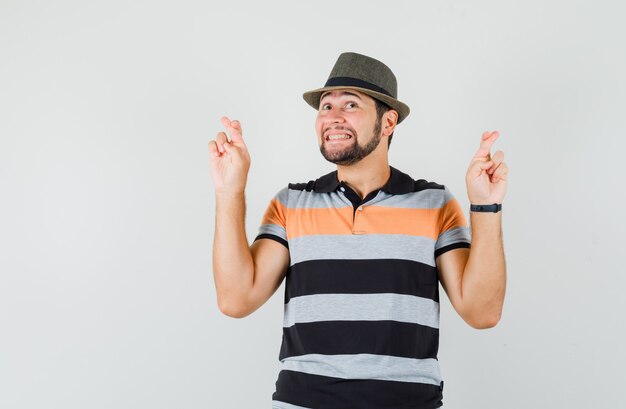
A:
[289,234,435,267]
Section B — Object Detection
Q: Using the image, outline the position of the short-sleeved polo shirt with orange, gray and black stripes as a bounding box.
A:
[255,166,470,409]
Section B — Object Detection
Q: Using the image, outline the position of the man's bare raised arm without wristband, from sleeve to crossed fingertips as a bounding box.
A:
[209,117,289,318]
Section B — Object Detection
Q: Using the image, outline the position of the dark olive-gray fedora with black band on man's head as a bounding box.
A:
[302,52,410,123]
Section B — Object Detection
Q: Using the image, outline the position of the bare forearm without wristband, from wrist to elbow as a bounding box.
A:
[213,192,254,314]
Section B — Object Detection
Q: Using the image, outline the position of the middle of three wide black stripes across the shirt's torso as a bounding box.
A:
[279,321,439,360]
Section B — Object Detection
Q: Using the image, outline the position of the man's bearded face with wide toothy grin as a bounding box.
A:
[315,89,381,166]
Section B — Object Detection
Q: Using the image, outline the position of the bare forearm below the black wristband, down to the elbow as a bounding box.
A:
[462,212,506,327]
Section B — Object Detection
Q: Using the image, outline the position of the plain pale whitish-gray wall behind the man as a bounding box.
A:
[0,0,626,409]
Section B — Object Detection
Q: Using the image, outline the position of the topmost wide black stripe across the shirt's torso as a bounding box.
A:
[285,259,439,302]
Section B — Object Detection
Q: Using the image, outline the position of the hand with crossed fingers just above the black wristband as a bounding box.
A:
[465,131,509,204]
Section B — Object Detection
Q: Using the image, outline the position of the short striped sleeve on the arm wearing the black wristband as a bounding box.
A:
[435,186,472,258]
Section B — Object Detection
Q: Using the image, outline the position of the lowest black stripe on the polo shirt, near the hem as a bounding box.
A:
[272,369,443,409]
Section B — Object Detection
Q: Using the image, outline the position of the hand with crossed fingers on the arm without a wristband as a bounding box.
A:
[209,116,250,193]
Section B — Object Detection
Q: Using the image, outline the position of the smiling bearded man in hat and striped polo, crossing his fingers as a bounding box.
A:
[209,53,508,409]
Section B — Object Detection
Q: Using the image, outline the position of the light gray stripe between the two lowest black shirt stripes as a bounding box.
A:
[283,354,441,385]
